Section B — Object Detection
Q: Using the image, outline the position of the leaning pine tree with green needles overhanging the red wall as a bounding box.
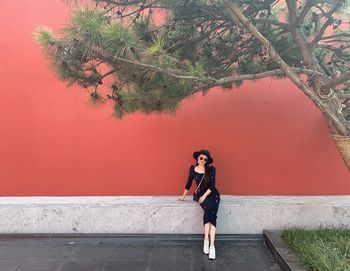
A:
[35,0,350,172]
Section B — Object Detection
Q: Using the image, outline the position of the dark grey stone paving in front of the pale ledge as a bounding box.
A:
[0,235,281,271]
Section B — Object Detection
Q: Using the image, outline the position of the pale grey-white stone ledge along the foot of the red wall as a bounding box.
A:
[0,195,350,234]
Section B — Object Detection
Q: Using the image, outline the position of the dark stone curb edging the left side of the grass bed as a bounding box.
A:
[263,230,308,271]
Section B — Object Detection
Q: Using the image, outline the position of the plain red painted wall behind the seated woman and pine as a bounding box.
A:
[0,0,350,196]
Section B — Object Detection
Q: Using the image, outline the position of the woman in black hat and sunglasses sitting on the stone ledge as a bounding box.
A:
[178,149,220,259]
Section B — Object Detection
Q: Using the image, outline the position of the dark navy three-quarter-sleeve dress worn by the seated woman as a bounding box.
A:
[185,165,220,227]
